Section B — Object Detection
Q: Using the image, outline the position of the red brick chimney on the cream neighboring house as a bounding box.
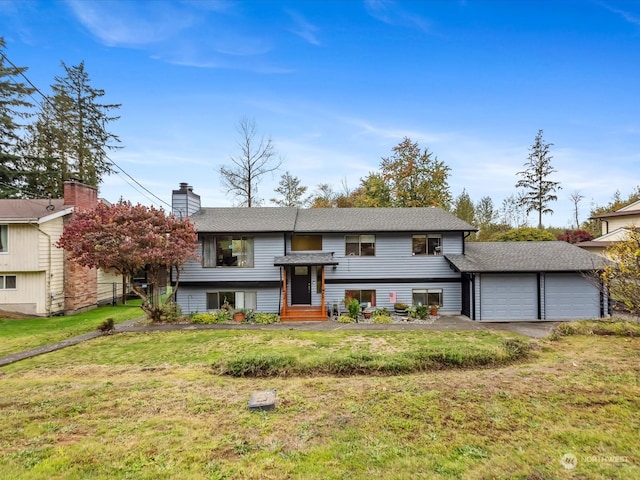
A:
[64,179,98,312]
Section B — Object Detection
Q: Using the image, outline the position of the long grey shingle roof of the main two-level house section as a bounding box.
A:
[191,207,477,233]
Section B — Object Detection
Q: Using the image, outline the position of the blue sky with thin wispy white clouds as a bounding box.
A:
[0,0,640,226]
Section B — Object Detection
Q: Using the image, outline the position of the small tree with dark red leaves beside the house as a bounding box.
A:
[56,202,198,322]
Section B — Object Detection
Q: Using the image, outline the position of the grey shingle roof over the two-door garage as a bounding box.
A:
[445,242,606,273]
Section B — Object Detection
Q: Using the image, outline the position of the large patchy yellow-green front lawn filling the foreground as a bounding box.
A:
[0,331,640,480]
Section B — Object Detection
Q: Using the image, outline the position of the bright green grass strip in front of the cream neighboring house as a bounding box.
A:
[0,300,144,356]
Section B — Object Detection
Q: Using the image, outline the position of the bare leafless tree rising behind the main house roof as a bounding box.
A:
[219,117,282,207]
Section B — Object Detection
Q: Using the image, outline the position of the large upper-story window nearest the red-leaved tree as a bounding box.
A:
[202,235,254,268]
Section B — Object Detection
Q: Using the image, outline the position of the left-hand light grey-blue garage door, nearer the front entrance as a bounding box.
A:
[480,274,538,320]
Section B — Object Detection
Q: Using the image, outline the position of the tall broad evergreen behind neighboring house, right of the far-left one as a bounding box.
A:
[23,62,120,196]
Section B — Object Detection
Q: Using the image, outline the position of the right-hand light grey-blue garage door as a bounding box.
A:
[544,273,600,320]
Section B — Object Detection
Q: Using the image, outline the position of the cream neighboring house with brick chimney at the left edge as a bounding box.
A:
[0,181,122,316]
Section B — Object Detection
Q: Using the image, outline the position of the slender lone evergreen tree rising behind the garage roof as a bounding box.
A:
[516,130,562,229]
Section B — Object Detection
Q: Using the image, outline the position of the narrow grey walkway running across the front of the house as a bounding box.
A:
[0,315,559,367]
